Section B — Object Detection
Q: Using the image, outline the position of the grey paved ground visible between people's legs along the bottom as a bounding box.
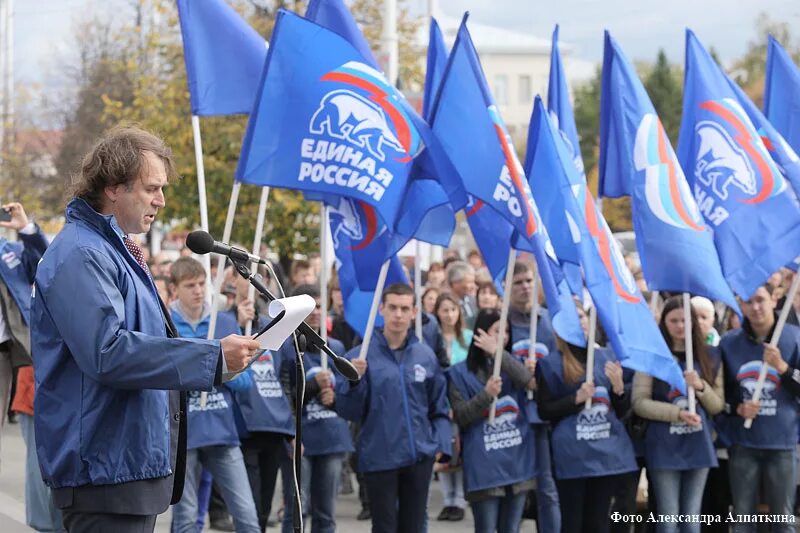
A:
[0,424,535,533]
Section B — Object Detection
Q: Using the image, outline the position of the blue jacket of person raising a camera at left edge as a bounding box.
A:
[0,227,47,325]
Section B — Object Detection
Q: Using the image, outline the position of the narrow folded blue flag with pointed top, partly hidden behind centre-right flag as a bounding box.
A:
[548,24,586,297]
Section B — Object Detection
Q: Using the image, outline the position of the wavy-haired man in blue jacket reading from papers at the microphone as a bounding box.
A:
[31,128,259,533]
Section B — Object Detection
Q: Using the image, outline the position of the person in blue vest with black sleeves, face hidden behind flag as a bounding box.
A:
[536,308,638,533]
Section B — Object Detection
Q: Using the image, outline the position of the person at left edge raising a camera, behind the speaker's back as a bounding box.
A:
[0,202,47,468]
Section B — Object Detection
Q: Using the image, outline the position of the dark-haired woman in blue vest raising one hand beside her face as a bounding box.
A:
[447,309,536,533]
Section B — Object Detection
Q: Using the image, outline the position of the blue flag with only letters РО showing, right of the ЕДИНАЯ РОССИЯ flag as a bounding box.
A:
[430,16,585,344]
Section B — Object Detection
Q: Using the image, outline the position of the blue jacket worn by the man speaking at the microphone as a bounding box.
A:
[31,199,220,488]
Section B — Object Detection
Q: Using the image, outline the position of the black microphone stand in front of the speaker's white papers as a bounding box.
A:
[233,259,359,533]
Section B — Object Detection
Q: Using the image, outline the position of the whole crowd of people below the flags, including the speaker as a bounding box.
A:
[0,128,800,533]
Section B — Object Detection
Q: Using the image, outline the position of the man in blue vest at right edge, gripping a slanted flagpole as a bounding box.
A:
[719,285,800,531]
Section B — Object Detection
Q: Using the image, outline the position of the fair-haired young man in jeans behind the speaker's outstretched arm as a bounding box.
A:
[170,257,260,533]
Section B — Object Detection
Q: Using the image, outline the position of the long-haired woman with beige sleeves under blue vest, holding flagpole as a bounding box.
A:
[632,297,725,532]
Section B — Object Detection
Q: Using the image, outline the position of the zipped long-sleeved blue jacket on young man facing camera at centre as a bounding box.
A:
[336,330,453,472]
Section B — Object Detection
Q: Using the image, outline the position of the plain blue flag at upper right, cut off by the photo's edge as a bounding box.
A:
[764,35,800,153]
